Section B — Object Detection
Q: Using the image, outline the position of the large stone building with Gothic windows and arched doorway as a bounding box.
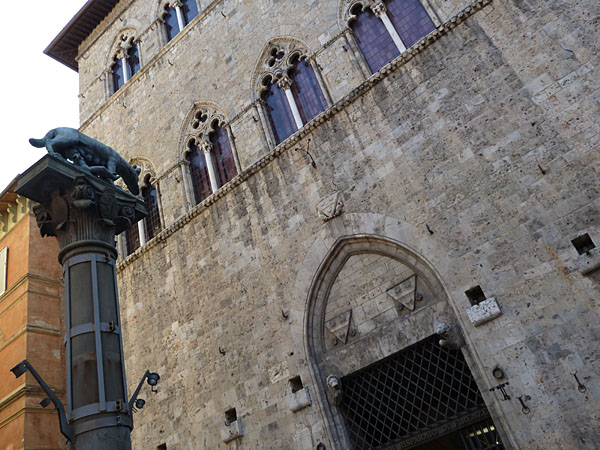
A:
[47,0,600,450]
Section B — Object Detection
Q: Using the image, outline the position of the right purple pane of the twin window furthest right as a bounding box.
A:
[386,0,435,48]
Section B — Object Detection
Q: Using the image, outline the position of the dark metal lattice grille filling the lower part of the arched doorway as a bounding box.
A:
[342,335,503,450]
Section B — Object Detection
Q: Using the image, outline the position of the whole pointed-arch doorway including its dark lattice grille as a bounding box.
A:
[305,235,505,450]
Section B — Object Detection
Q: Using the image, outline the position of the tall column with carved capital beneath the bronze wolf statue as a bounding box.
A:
[16,155,147,450]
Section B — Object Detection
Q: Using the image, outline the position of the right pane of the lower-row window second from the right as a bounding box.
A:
[292,61,327,123]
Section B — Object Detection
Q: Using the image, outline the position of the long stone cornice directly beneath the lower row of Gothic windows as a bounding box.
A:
[117,0,493,272]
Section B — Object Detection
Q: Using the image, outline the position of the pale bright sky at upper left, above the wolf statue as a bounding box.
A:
[0,0,86,192]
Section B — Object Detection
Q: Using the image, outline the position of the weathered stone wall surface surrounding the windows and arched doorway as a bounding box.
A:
[70,0,600,449]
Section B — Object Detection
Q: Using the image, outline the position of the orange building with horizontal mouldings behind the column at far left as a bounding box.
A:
[0,183,65,450]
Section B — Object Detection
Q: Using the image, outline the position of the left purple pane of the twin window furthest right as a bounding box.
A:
[351,5,400,73]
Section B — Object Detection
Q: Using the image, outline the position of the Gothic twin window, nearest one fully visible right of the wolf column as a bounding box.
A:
[185,105,239,204]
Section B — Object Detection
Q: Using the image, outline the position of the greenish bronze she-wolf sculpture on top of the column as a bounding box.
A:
[29,127,140,195]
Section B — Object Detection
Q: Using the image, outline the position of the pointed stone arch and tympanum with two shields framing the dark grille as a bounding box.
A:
[304,235,502,449]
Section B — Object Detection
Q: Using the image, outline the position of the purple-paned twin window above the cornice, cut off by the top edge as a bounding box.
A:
[348,0,435,72]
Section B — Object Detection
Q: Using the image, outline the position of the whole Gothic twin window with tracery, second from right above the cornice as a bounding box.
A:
[258,42,327,144]
